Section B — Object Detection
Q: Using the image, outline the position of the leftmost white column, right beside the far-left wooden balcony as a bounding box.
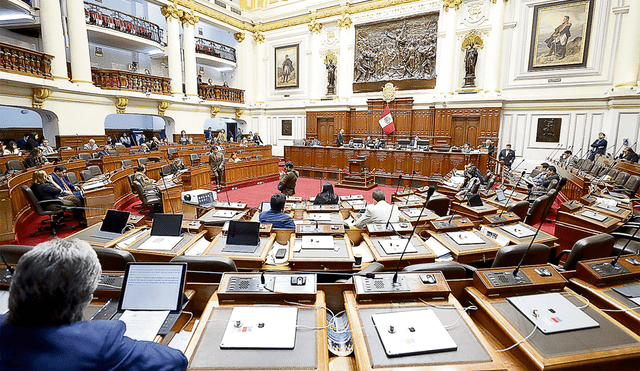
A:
[40,0,69,80]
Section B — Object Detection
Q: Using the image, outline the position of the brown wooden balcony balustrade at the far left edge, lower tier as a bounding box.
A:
[0,42,53,80]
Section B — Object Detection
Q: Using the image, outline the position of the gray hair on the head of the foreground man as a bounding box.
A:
[6,239,102,327]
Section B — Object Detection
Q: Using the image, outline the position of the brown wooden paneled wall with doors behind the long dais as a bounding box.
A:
[307,98,501,148]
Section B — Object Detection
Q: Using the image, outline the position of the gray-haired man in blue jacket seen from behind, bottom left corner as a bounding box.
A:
[0,239,187,371]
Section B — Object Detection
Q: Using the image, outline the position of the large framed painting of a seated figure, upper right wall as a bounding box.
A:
[529,0,595,72]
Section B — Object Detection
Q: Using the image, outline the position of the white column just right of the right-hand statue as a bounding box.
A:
[482,0,505,93]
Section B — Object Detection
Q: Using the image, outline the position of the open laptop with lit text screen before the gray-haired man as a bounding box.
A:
[111,263,187,335]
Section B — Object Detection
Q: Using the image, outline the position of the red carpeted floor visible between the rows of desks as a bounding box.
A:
[5,178,560,246]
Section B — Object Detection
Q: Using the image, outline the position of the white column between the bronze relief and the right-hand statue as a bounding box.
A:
[437,8,458,94]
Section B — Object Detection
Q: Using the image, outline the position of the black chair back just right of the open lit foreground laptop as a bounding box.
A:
[171,255,238,283]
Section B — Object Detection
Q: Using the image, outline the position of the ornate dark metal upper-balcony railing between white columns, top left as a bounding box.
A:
[84,3,163,45]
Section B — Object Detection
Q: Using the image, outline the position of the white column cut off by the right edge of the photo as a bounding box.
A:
[613,1,640,87]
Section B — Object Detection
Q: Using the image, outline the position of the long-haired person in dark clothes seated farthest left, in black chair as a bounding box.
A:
[31,170,87,227]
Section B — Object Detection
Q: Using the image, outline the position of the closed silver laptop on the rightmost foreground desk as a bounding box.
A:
[507,292,600,334]
